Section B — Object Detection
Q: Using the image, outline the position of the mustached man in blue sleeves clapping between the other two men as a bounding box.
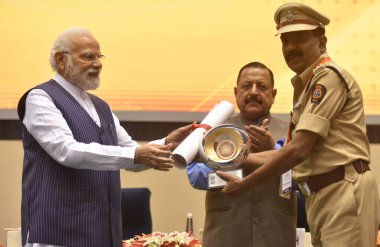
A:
[187,62,296,247]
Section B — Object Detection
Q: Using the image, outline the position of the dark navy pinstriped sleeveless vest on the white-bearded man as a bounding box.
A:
[17,80,122,247]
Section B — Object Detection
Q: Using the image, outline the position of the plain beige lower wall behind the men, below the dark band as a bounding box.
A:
[0,141,380,243]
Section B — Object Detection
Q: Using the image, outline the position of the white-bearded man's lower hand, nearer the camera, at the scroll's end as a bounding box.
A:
[135,144,174,171]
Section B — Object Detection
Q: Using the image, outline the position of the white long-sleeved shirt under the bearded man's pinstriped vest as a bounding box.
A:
[22,74,165,247]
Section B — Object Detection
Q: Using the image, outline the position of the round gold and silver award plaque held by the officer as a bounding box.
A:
[199,124,249,189]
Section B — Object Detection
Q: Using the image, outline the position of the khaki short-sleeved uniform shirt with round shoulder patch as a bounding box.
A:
[291,54,370,181]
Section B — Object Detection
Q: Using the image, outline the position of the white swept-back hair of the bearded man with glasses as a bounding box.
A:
[49,27,92,71]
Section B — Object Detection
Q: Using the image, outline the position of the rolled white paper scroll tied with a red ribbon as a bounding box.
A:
[172,100,234,169]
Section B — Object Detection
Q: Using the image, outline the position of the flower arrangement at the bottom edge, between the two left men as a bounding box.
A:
[123,232,202,247]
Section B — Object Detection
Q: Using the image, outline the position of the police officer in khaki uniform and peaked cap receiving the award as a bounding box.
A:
[218,3,380,247]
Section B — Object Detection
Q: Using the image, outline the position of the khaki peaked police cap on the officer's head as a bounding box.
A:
[274,3,330,34]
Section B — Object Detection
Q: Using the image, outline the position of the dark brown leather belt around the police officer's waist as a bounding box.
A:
[298,160,370,198]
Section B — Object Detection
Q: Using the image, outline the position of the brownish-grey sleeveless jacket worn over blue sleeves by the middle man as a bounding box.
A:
[202,115,297,247]
